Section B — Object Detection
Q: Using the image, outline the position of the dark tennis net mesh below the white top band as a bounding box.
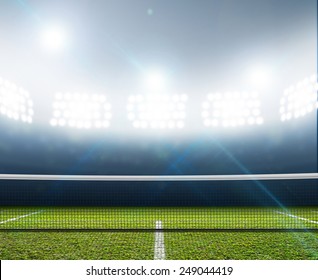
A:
[0,175,318,231]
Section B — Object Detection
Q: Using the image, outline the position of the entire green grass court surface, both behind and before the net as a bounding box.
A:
[0,207,318,260]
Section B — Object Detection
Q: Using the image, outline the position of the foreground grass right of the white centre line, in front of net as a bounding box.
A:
[165,232,318,260]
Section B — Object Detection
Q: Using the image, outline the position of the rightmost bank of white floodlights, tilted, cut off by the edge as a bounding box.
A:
[279,74,318,122]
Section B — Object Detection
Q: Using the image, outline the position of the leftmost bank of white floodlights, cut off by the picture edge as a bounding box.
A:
[0,77,34,123]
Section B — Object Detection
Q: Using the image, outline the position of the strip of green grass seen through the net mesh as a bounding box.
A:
[0,207,318,229]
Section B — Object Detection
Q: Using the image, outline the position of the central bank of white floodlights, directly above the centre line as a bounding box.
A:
[127,94,188,130]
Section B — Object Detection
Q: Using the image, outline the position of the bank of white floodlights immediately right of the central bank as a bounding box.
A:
[201,92,264,127]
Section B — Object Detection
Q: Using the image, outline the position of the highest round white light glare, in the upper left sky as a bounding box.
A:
[42,25,68,51]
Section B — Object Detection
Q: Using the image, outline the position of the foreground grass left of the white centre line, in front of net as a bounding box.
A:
[0,232,154,260]
